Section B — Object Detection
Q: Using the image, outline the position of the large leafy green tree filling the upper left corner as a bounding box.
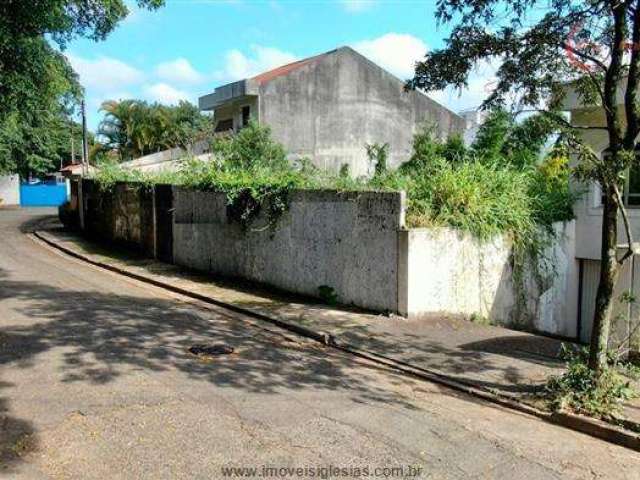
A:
[0,0,164,174]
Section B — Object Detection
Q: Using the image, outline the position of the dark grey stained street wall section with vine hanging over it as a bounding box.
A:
[173,188,404,311]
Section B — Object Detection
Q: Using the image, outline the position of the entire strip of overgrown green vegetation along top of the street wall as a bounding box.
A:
[91,111,576,238]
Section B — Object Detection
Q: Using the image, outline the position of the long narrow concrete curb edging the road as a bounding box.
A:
[31,231,640,452]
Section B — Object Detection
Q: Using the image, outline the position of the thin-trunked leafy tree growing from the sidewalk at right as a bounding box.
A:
[408,0,640,378]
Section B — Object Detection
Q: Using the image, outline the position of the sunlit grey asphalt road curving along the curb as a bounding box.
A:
[0,210,640,480]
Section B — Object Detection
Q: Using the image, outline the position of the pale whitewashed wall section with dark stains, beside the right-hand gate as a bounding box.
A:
[400,222,577,336]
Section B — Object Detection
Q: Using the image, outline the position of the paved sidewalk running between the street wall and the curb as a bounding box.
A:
[32,223,640,430]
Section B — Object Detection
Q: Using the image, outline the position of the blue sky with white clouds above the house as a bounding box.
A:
[65,0,493,129]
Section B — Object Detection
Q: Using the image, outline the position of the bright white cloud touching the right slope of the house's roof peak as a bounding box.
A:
[352,33,427,80]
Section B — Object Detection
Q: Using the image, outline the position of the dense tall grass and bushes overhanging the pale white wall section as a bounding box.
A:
[380,110,577,238]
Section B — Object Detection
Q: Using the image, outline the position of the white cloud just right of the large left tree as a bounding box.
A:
[67,53,144,92]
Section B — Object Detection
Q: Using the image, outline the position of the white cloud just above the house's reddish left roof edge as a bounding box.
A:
[214,45,297,82]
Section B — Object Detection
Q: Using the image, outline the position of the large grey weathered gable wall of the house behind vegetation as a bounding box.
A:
[259,47,465,175]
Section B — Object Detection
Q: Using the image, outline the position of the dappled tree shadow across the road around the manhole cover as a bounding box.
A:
[0,272,415,470]
